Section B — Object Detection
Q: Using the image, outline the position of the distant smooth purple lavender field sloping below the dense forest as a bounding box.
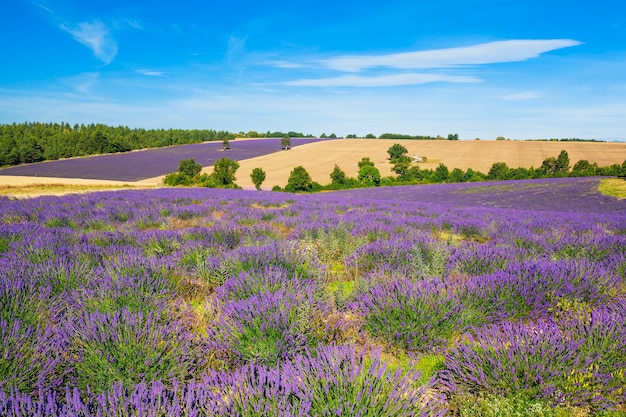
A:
[0,138,325,181]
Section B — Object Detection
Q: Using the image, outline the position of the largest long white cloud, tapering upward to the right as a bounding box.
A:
[314,39,581,72]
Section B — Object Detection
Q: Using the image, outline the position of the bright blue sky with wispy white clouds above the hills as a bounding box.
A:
[0,0,626,140]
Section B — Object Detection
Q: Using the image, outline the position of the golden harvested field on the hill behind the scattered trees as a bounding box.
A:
[230,139,626,188]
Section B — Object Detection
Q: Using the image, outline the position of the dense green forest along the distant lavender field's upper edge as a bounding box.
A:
[0,122,235,166]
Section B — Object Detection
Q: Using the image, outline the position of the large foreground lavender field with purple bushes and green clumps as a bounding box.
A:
[0,179,626,417]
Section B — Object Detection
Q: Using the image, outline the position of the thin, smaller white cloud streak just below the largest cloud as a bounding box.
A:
[284,74,480,87]
